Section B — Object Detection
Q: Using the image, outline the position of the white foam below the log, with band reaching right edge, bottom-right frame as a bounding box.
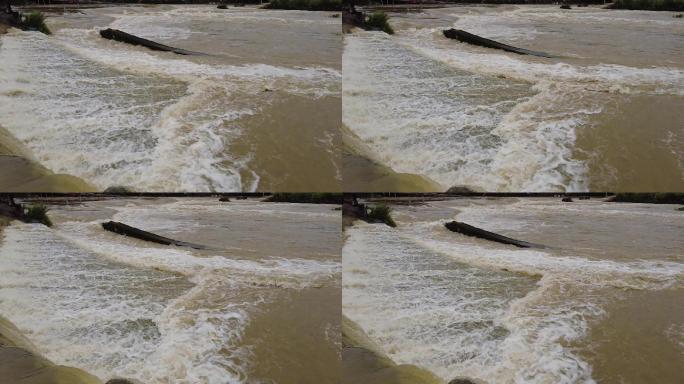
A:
[343,222,684,383]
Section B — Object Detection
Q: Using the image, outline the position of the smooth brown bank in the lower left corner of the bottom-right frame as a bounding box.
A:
[342,315,443,384]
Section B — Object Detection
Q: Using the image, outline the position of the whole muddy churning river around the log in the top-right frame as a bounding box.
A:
[343,5,684,191]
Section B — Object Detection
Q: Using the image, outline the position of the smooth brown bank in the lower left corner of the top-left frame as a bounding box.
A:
[0,126,96,192]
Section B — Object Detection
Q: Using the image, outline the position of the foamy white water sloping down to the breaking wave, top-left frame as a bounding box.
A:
[0,32,252,191]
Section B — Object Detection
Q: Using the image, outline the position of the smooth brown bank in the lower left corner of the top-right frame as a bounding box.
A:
[341,126,445,192]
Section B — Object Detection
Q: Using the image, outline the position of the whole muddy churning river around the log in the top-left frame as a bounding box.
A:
[0,6,341,191]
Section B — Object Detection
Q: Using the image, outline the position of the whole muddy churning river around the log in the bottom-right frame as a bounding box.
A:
[343,199,684,384]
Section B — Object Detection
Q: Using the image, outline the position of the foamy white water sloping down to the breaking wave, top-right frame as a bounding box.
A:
[343,33,600,191]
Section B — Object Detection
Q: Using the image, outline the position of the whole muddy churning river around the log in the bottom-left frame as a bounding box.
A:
[0,199,340,384]
